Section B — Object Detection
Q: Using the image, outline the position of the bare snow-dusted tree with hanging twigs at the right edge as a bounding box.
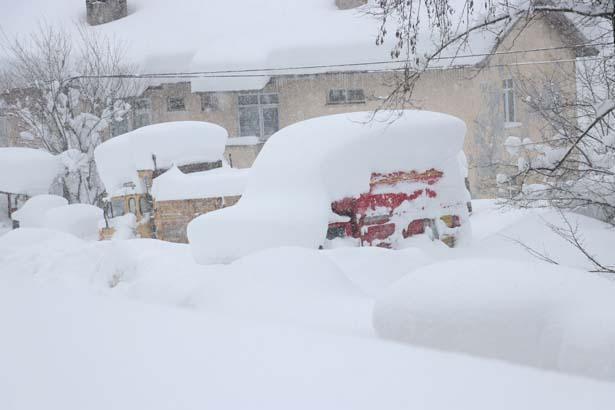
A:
[371,0,615,271]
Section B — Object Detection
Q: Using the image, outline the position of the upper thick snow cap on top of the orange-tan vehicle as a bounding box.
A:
[94,121,228,196]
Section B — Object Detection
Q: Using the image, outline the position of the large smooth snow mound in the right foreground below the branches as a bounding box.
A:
[373,259,615,380]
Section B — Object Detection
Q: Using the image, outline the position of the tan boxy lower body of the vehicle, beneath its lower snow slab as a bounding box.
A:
[154,196,240,243]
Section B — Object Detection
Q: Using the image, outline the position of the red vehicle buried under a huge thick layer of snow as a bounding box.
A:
[188,110,469,263]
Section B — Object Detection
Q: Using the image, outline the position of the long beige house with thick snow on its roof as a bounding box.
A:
[0,0,596,197]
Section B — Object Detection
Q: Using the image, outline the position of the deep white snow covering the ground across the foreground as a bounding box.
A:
[0,201,615,410]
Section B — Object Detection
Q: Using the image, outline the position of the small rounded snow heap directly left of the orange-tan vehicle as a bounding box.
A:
[44,204,103,240]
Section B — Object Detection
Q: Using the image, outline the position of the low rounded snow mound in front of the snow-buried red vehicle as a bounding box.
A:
[192,247,371,330]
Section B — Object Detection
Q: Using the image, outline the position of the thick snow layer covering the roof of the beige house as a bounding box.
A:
[0,0,506,91]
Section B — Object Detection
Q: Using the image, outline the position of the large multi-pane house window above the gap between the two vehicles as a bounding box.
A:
[238,93,280,138]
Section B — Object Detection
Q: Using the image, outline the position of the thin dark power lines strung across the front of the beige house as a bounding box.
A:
[71,43,612,80]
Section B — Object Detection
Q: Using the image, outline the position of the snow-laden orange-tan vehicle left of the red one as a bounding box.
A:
[94,121,244,242]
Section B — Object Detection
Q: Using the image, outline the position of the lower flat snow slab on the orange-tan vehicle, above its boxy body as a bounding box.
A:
[152,167,250,201]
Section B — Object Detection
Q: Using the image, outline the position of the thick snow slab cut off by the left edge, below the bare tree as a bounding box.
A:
[0,148,64,196]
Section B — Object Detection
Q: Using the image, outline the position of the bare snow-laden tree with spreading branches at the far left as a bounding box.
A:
[2,26,135,204]
